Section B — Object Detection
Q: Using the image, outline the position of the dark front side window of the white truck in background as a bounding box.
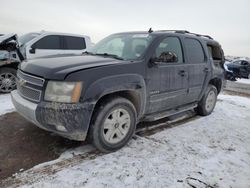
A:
[32,35,61,50]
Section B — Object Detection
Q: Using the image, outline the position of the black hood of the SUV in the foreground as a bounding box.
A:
[19,55,121,80]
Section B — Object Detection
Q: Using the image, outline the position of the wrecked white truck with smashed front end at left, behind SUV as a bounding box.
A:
[0,31,92,93]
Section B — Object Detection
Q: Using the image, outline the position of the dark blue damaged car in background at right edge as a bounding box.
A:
[225,60,250,81]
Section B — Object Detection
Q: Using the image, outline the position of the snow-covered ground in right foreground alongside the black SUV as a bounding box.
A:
[11,95,250,188]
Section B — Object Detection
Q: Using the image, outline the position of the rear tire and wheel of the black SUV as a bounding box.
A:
[196,84,218,116]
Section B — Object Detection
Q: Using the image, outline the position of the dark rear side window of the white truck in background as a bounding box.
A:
[64,36,86,50]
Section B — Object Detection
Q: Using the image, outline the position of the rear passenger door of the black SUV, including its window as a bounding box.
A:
[184,38,211,103]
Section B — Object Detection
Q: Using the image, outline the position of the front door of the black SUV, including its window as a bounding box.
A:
[147,37,188,114]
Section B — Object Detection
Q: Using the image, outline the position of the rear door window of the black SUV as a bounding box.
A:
[185,38,205,63]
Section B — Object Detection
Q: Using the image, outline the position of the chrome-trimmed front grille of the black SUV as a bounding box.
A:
[17,70,45,102]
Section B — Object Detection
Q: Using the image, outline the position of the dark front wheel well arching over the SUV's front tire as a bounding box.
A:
[94,90,141,116]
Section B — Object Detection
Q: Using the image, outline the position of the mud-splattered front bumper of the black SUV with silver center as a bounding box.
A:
[11,90,94,141]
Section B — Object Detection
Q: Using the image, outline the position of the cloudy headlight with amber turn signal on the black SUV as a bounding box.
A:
[44,81,82,103]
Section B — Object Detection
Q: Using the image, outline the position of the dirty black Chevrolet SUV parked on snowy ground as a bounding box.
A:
[12,30,224,152]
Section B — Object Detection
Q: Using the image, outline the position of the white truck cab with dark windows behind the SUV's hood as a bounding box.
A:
[18,32,91,59]
